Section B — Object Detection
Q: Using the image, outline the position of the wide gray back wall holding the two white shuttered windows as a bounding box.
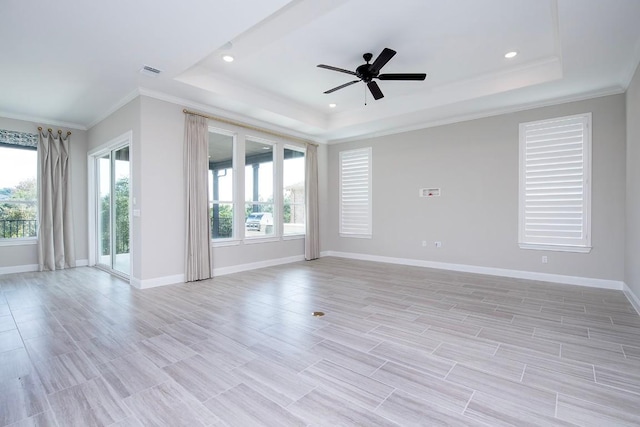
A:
[326,95,625,281]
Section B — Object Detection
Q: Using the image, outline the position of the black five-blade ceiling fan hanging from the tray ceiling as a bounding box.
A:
[318,47,427,100]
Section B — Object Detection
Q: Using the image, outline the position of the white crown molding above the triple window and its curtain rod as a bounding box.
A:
[138,87,327,144]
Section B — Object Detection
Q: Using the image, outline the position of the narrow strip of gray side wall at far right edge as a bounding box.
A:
[624,66,640,300]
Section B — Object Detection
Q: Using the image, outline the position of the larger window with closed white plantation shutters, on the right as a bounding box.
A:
[519,113,591,252]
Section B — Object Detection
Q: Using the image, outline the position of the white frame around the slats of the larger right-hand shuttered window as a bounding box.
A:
[518,113,593,253]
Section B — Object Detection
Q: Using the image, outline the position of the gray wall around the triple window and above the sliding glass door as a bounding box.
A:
[89,96,327,286]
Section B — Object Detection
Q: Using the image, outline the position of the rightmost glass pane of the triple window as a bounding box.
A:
[282,148,305,236]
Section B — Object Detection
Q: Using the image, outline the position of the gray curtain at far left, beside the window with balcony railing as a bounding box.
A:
[38,131,76,271]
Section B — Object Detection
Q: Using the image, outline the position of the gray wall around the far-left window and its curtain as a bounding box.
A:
[0,117,88,270]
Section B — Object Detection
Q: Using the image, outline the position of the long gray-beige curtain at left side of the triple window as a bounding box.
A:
[184,114,212,282]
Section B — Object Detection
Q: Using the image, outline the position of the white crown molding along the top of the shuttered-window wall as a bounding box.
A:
[327,87,626,145]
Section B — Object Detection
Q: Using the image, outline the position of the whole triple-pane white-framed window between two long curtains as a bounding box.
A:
[209,127,305,246]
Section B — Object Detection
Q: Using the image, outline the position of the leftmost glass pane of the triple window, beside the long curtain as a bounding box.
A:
[209,131,235,240]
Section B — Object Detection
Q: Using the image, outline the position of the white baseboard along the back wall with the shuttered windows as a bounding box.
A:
[322,251,624,291]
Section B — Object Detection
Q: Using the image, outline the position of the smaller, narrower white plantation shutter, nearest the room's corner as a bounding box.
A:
[340,147,372,237]
